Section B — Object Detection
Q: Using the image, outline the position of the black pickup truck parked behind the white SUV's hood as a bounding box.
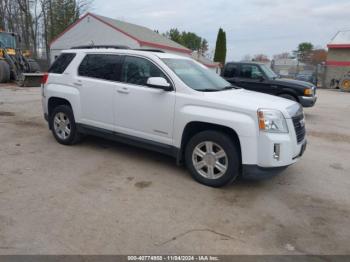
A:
[221,62,317,107]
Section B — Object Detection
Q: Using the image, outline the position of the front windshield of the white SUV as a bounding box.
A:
[162,58,231,91]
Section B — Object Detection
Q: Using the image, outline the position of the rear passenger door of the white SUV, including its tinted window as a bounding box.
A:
[73,54,121,131]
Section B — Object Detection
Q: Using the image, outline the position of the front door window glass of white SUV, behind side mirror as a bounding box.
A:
[121,56,169,85]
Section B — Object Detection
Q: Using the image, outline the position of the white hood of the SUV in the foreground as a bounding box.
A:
[203,89,300,118]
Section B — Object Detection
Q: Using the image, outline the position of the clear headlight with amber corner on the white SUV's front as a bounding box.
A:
[258,109,288,133]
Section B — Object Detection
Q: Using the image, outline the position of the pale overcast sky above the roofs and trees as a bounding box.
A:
[89,0,350,61]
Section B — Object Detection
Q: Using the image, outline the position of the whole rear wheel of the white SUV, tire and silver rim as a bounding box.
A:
[50,105,80,145]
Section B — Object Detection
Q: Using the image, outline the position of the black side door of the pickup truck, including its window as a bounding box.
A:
[237,64,271,93]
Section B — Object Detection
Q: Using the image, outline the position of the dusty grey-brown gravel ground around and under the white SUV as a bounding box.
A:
[0,85,350,254]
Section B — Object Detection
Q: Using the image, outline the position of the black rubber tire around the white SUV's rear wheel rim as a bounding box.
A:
[50,105,81,145]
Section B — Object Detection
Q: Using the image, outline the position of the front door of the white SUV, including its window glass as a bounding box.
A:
[114,56,175,145]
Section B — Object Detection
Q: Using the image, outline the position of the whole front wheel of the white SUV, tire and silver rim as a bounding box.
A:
[185,131,240,187]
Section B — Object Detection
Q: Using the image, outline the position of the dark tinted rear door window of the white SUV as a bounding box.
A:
[78,54,121,81]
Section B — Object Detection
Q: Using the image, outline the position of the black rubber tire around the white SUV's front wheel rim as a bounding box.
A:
[185,130,241,187]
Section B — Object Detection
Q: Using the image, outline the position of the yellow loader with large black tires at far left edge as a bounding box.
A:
[0,30,43,86]
